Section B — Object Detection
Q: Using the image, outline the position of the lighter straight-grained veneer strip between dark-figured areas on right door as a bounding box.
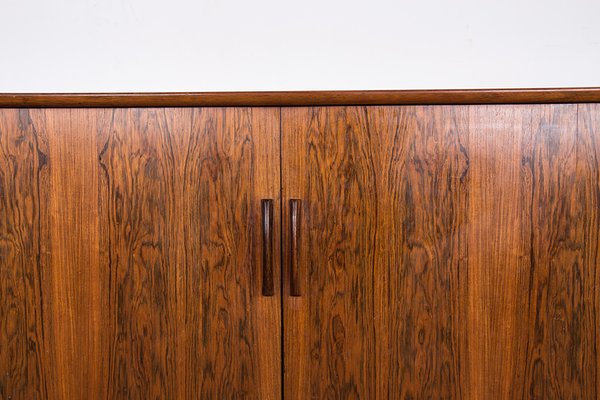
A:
[463,106,542,399]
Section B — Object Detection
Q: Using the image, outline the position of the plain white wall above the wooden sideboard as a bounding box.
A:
[0,0,600,92]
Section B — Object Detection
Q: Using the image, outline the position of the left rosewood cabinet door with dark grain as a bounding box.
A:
[0,108,281,399]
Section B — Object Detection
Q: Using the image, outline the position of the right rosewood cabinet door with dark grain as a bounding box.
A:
[282,104,600,400]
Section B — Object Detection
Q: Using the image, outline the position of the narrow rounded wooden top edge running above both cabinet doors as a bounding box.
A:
[0,87,600,108]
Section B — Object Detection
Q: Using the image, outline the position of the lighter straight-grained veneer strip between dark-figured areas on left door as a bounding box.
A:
[45,109,110,399]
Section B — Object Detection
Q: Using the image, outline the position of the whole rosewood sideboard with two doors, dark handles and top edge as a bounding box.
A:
[0,88,600,399]
